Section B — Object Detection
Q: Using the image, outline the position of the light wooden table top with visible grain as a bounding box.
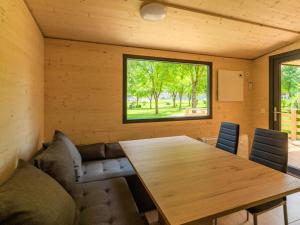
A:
[120,136,300,225]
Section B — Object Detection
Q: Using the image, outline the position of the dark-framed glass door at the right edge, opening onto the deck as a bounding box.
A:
[270,51,300,176]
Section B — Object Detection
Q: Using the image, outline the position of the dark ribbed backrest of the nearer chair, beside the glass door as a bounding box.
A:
[250,128,288,173]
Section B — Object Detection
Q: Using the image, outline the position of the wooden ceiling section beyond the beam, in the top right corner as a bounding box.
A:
[166,0,300,31]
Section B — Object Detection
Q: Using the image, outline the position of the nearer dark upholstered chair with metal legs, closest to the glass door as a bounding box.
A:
[247,128,288,225]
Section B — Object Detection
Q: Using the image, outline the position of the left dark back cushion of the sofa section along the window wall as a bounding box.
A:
[76,143,105,161]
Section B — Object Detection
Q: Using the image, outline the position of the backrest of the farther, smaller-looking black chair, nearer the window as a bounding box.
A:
[216,122,240,154]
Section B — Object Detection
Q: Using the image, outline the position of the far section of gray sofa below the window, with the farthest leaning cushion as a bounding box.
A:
[50,131,135,183]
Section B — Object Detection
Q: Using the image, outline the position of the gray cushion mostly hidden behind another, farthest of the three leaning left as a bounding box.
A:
[53,130,82,179]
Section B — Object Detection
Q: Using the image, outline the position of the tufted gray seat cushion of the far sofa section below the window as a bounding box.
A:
[79,158,135,183]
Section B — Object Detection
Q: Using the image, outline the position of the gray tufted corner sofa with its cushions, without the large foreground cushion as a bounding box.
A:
[28,131,155,225]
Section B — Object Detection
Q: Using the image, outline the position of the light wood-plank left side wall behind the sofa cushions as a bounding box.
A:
[0,0,44,183]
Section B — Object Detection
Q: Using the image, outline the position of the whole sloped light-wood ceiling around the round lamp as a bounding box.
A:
[26,0,300,59]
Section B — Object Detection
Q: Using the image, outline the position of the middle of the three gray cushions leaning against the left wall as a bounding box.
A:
[34,140,76,193]
